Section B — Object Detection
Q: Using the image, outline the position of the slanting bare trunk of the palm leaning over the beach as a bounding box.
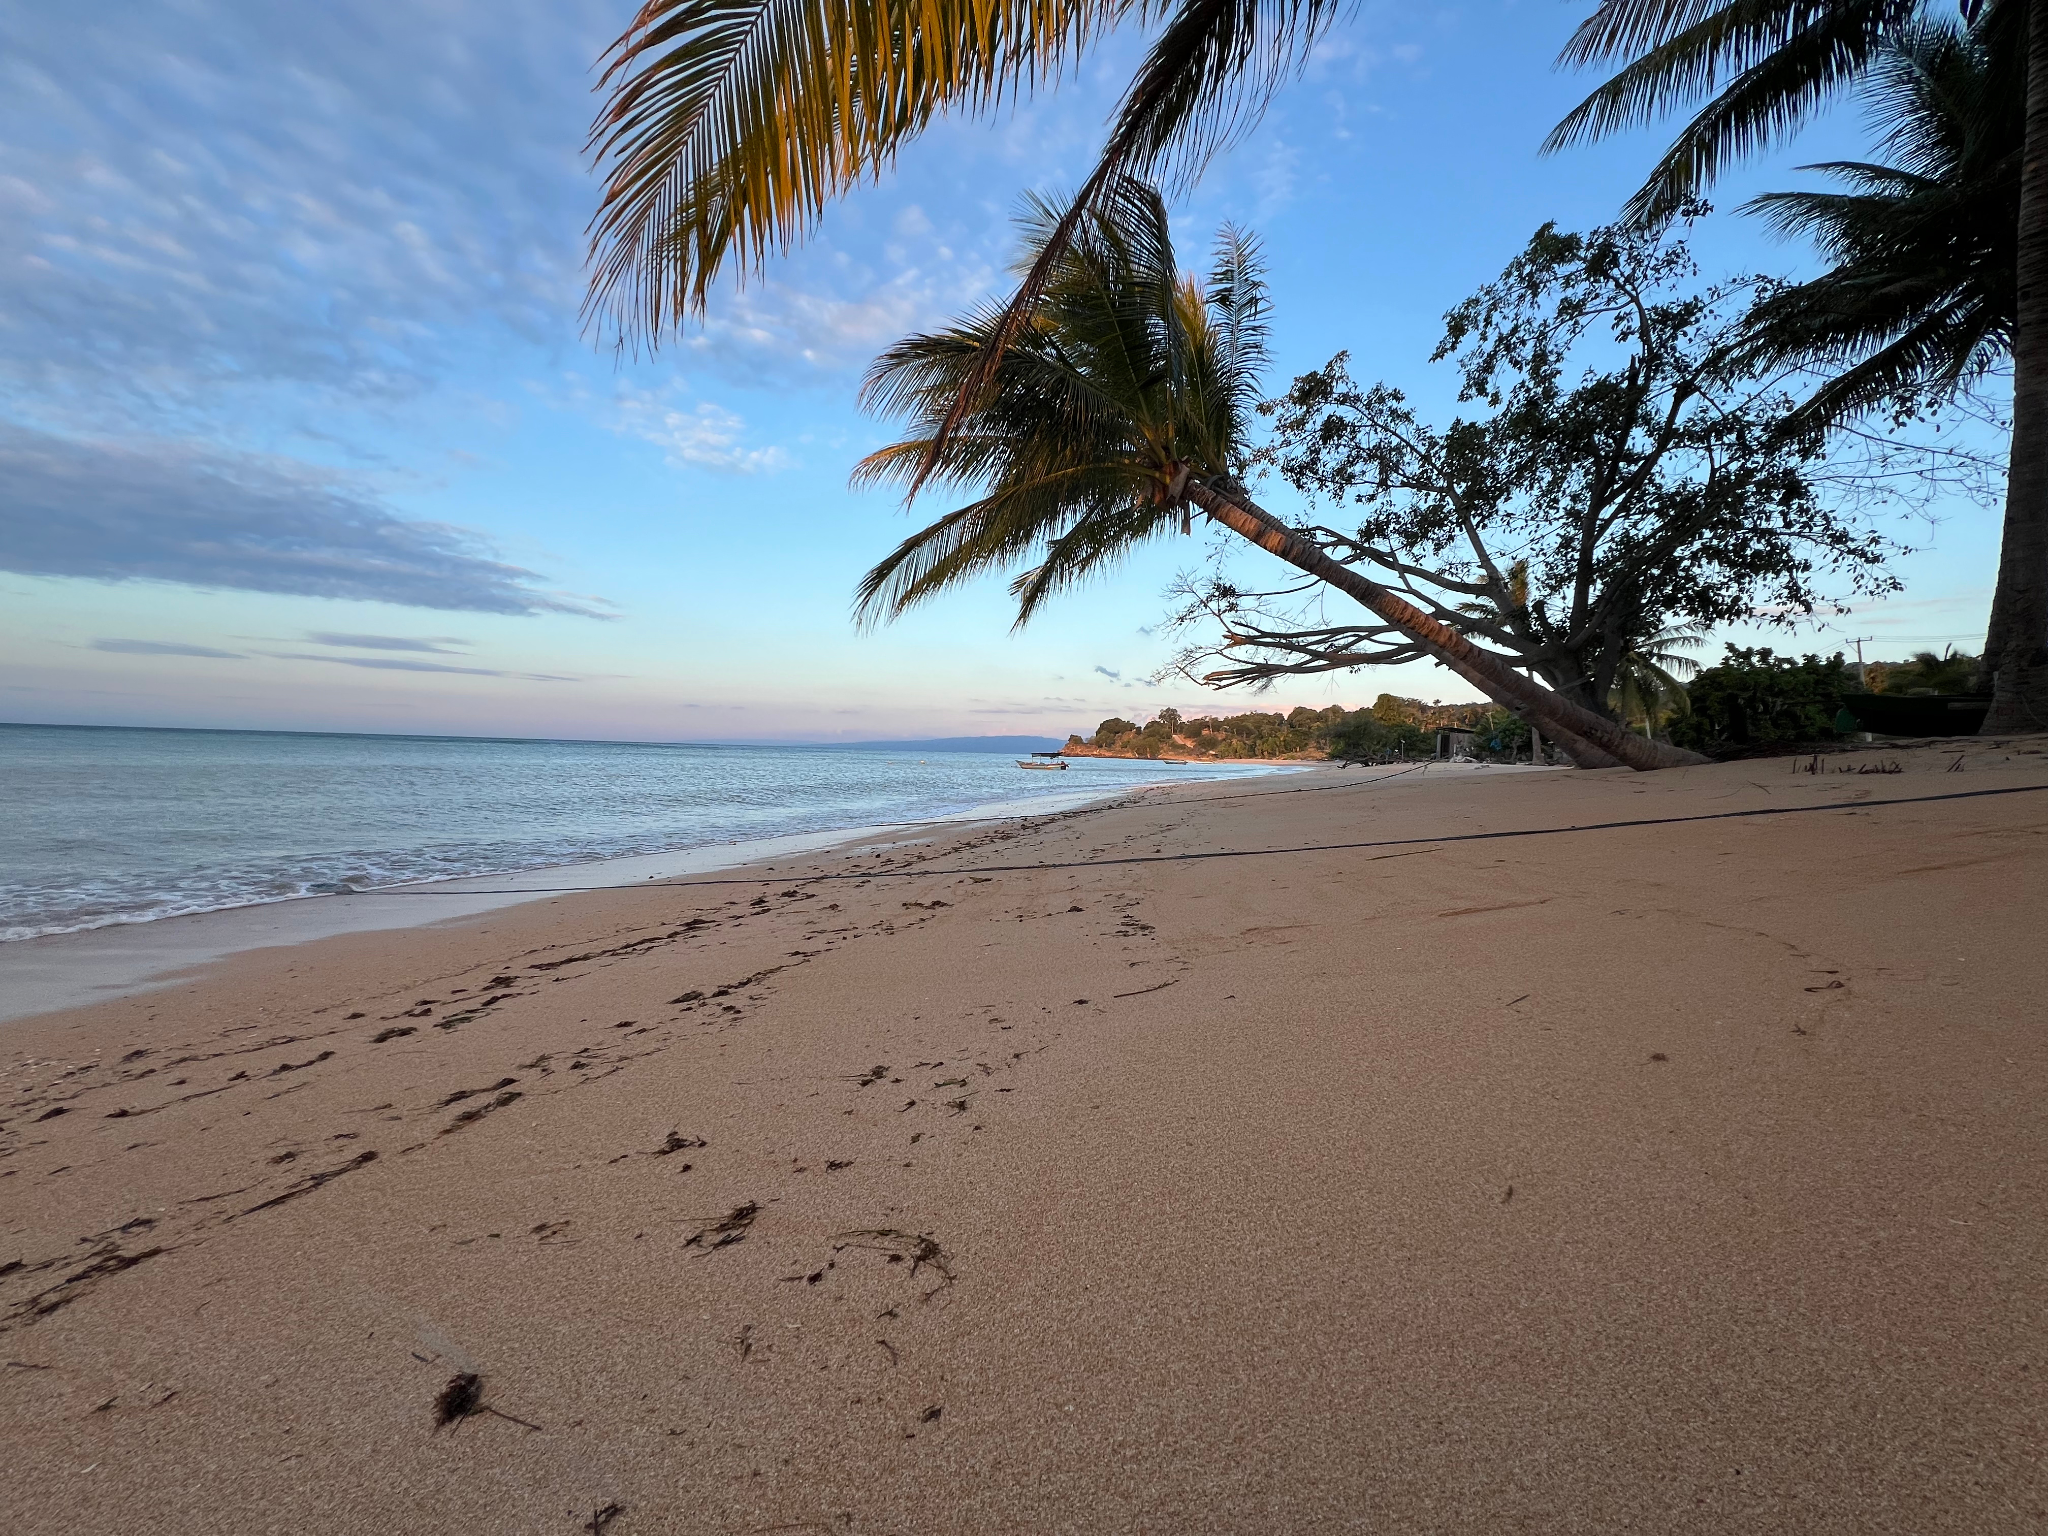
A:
[1184,479,1706,770]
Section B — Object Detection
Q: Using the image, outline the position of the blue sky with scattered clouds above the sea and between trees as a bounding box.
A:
[0,0,1997,741]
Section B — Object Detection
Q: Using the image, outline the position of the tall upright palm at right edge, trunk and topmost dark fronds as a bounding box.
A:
[1546,0,2048,731]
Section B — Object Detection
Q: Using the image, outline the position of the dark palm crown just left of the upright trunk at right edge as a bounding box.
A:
[1745,25,2025,428]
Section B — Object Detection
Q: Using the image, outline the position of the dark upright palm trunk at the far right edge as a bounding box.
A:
[1985,0,2048,733]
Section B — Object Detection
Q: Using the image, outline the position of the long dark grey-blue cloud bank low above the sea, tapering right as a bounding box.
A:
[0,422,600,616]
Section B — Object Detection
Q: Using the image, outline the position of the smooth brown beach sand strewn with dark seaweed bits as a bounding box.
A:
[0,741,2048,1536]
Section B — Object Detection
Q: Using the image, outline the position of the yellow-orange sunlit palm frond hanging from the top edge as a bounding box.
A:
[590,0,1141,340]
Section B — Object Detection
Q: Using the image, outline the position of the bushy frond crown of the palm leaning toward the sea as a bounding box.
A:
[854,184,1264,625]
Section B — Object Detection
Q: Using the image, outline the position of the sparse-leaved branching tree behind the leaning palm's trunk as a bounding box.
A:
[1182,225,1896,719]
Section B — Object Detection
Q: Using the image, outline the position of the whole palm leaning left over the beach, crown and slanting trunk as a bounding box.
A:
[854,178,1702,768]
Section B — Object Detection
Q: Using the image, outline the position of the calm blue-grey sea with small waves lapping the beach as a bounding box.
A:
[0,725,1262,942]
